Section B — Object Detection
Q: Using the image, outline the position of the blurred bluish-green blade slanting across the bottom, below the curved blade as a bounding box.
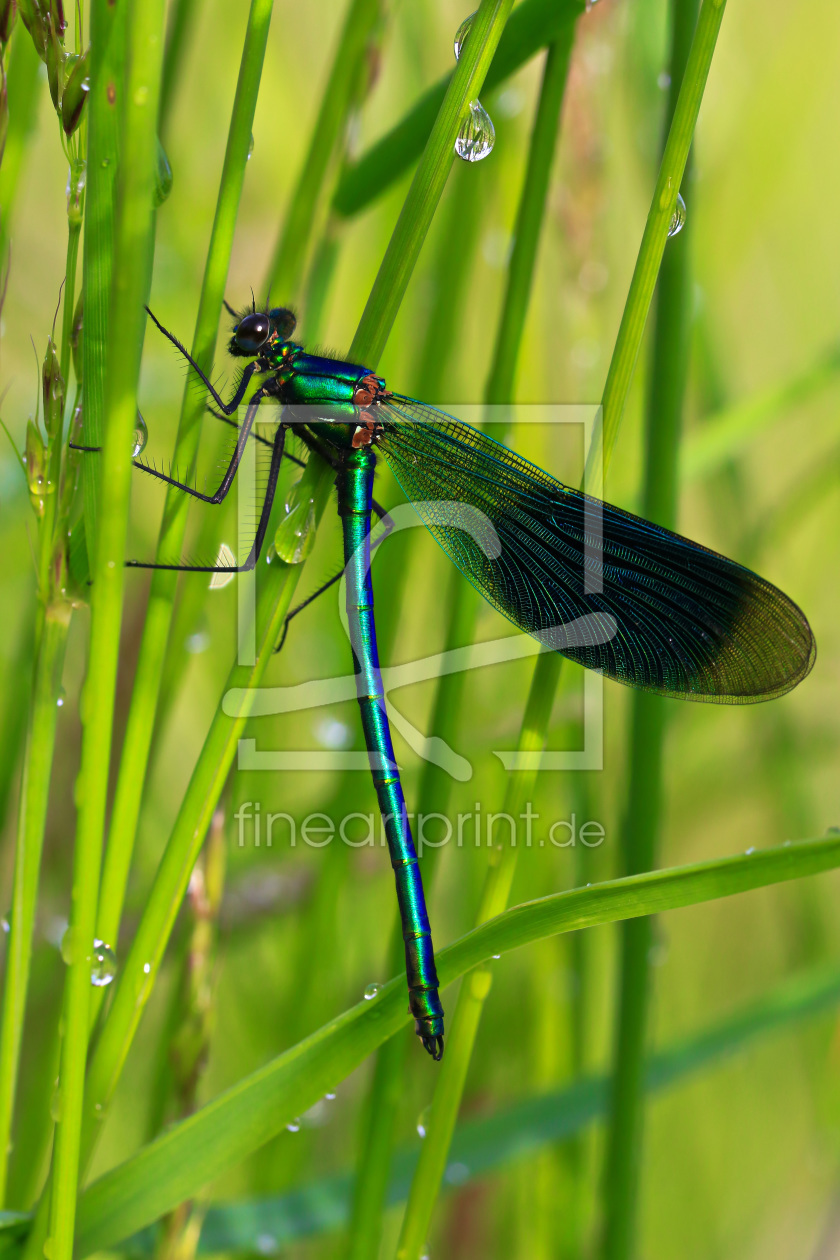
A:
[178,966,840,1255]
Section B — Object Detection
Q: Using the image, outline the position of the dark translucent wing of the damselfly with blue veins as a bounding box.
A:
[378,396,816,704]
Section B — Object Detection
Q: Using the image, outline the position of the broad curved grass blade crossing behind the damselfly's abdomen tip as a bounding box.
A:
[77,834,840,1256]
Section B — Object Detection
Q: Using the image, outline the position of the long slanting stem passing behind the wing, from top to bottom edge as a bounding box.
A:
[399,0,724,1239]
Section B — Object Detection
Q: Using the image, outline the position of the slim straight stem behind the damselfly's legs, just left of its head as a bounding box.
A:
[95,0,273,972]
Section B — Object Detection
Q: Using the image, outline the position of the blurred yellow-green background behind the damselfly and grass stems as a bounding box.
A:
[0,0,840,1260]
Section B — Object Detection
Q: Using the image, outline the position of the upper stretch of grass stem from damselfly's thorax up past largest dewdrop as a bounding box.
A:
[349,0,513,364]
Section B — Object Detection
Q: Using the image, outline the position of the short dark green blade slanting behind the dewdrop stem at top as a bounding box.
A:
[332,0,583,218]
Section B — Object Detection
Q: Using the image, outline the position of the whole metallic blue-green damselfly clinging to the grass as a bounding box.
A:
[83,299,816,1058]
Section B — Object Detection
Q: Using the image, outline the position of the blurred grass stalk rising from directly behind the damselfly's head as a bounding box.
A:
[268,0,383,300]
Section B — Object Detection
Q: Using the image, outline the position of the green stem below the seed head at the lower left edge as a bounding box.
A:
[0,602,71,1205]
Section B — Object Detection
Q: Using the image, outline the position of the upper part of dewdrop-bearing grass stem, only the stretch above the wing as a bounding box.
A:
[587,0,727,484]
